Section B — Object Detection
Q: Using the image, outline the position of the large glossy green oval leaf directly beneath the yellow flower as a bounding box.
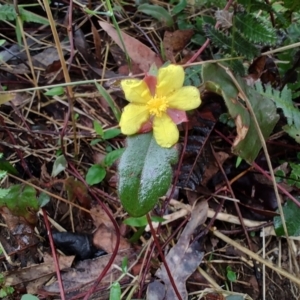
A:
[118,133,178,217]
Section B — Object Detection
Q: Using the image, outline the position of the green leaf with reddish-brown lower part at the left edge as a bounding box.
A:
[0,184,39,224]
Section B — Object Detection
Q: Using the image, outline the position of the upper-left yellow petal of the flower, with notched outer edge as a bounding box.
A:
[121,79,151,104]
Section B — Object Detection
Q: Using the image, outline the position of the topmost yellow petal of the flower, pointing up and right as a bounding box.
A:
[156,65,184,97]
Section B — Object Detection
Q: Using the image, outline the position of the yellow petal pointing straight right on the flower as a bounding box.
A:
[166,86,201,110]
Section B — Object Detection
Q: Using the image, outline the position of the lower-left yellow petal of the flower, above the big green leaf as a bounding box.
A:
[120,104,150,135]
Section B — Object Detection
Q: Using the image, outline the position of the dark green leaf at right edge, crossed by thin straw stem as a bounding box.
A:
[273,199,300,236]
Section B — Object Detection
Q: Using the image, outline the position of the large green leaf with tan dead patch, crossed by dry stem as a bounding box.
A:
[202,64,279,163]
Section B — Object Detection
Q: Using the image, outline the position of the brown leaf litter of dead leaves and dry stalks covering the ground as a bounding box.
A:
[0,1,300,299]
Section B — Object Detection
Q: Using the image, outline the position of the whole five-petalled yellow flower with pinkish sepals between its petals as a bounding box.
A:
[120,65,201,148]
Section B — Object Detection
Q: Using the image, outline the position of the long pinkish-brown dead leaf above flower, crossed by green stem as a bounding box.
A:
[99,21,162,73]
